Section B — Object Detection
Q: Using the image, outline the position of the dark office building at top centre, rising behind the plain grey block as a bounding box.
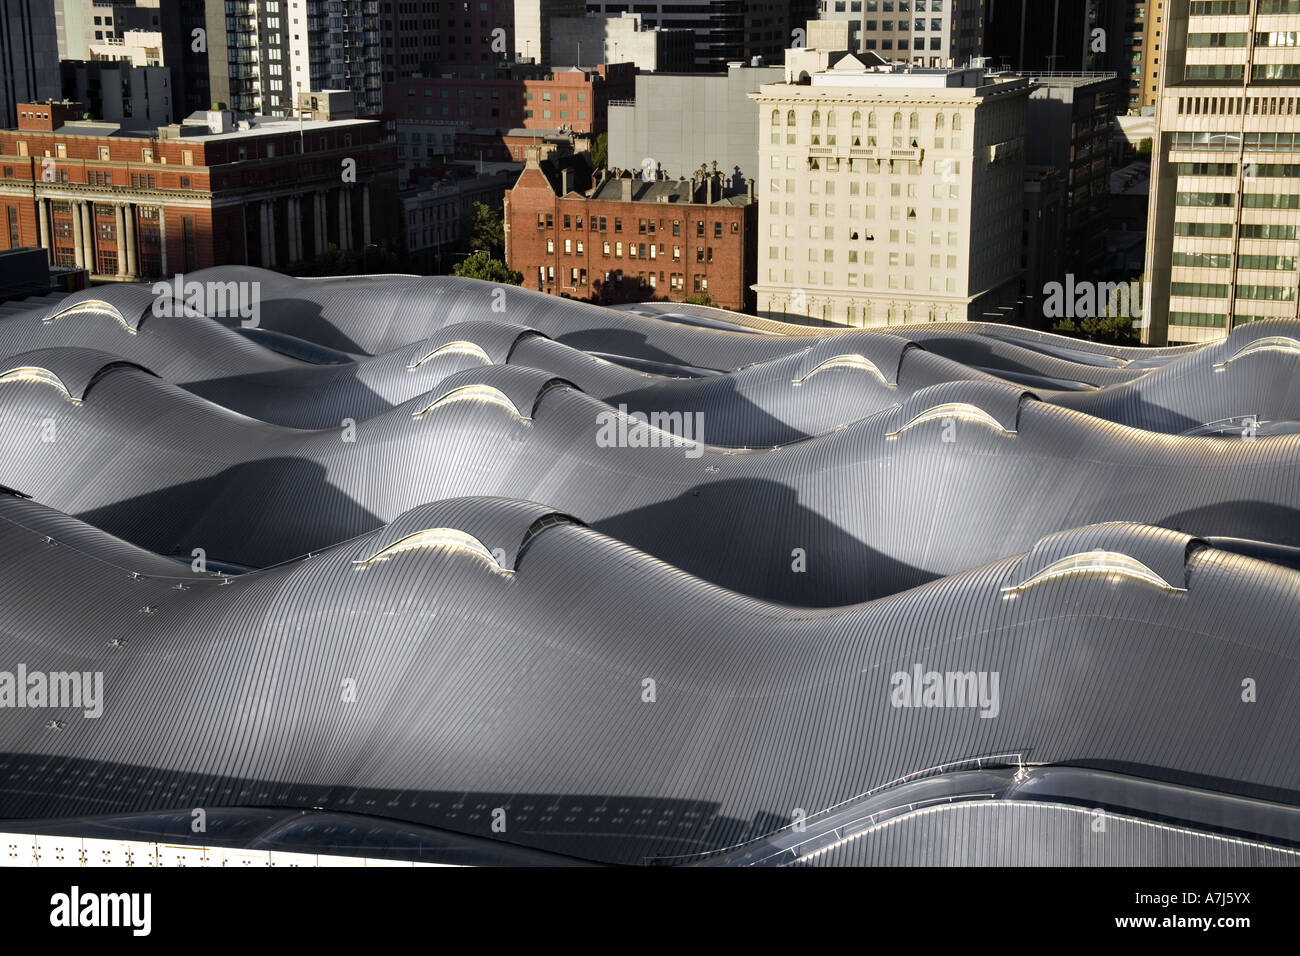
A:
[586,0,814,73]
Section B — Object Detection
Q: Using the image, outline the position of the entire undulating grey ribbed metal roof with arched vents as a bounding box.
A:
[0,268,1300,865]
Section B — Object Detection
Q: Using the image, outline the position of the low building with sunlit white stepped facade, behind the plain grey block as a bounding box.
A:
[550,13,696,73]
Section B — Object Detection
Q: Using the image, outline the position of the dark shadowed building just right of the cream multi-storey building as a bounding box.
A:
[1026,73,1118,276]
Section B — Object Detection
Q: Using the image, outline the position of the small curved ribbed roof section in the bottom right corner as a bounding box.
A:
[789,800,1300,866]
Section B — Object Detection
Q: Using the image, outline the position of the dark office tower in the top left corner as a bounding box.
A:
[0,0,62,129]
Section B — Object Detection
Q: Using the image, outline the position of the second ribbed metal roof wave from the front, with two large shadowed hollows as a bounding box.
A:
[0,359,1300,606]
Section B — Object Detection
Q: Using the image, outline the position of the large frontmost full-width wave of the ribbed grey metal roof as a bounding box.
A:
[0,501,1300,862]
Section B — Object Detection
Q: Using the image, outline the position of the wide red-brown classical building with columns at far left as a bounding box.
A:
[0,103,400,280]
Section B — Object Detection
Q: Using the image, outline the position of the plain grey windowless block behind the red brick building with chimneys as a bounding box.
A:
[608,64,784,177]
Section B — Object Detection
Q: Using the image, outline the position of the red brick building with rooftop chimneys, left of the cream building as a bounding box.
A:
[504,151,758,311]
